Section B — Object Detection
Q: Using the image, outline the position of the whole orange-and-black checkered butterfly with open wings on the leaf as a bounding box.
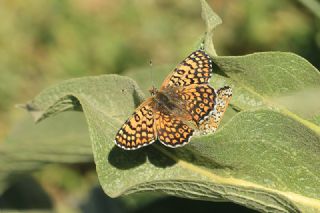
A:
[114,50,232,150]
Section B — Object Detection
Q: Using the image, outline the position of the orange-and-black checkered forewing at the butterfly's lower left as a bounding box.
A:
[115,99,156,150]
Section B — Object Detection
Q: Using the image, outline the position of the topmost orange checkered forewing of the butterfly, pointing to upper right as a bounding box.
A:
[160,50,212,89]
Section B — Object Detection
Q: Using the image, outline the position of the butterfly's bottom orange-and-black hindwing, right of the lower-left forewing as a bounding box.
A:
[155,111,194,148]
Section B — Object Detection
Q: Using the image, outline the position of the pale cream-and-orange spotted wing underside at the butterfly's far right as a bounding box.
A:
[199,86,232,134]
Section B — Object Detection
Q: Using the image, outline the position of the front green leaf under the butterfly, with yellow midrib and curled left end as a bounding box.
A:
[20,72,320,212]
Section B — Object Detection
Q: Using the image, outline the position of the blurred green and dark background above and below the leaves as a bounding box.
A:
[0,0,320,212]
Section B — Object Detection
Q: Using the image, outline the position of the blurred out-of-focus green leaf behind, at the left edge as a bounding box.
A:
[0,112,93,192]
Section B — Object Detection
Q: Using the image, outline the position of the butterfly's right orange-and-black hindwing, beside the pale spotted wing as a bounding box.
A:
[178,84,216,125]
